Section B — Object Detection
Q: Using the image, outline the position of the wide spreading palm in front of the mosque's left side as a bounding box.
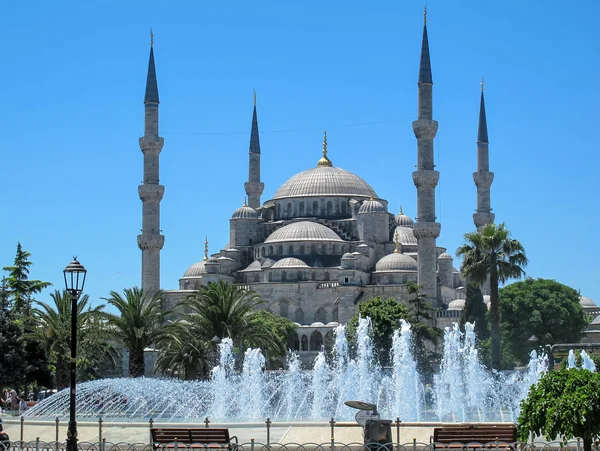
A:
[185,281,286,355]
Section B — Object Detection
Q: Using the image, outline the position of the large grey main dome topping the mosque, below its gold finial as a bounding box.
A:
[273,166,377,199]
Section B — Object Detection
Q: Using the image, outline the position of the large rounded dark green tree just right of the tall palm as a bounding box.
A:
[500,278,587,363]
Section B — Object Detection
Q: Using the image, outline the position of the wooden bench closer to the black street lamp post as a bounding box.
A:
[150,428,238,451]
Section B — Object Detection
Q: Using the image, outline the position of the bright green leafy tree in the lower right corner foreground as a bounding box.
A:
[517,369,600,451]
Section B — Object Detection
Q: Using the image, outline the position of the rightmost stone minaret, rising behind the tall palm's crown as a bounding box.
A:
[473,80,495,230]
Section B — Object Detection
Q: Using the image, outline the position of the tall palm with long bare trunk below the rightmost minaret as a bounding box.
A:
[456,224,527,370]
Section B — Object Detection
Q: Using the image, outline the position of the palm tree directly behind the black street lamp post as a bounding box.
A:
[32,290,112,389]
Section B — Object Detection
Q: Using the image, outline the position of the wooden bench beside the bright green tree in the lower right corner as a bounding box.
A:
[432,424,517,450]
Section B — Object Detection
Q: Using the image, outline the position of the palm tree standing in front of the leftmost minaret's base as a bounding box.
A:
[103,287,166,377]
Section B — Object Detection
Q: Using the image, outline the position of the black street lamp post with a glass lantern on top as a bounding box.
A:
[63,257,87,451]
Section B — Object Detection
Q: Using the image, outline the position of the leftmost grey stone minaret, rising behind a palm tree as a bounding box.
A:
[138,31,165,292]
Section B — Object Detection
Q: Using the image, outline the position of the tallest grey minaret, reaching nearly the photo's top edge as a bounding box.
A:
[413,9,440,307]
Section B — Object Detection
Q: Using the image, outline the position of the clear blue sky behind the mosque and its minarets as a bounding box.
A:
[0,0,600,310]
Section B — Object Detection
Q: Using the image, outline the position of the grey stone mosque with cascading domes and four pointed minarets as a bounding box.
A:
[132,16,596,353]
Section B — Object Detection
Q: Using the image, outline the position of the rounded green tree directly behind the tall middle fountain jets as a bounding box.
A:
[348,297,411,365]
